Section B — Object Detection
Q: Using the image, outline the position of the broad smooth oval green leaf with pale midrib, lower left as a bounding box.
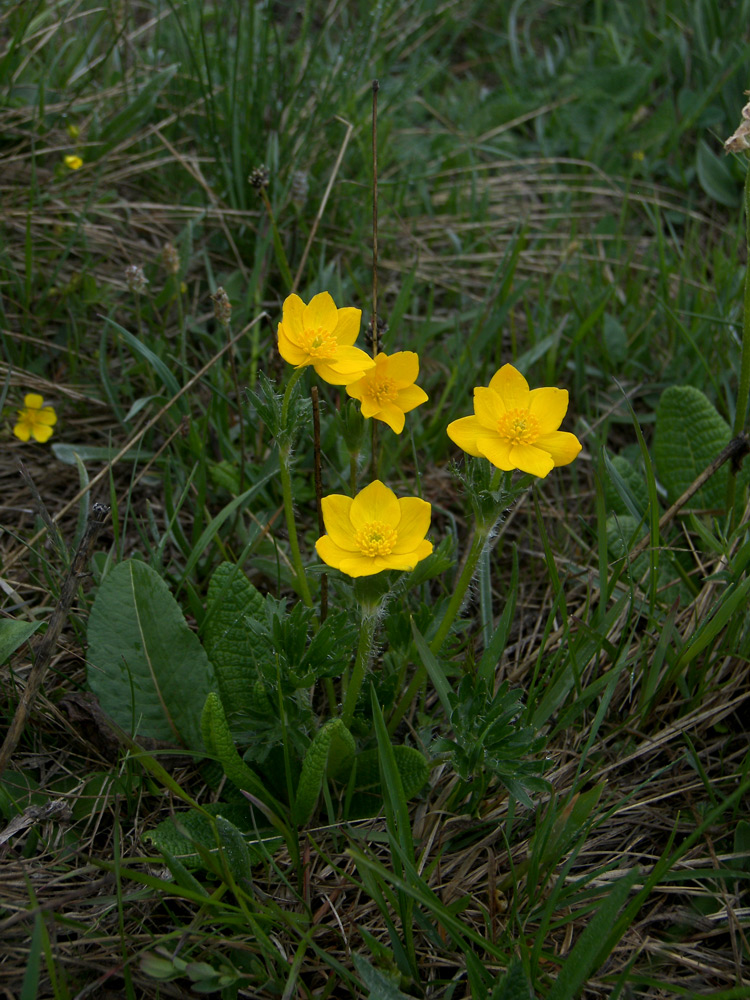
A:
[88,559,216,750]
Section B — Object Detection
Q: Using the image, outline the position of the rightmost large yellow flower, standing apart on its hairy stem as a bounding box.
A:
[448,365,581,476]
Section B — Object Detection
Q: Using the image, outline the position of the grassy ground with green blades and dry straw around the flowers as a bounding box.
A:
[0,0,750,1000]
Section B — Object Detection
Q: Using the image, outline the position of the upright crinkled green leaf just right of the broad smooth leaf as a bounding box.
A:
[203,562,263,712]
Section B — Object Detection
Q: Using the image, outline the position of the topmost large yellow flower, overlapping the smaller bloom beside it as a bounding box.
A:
[279,292,375,385]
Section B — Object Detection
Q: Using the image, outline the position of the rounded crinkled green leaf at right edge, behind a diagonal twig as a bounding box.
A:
[654,385,731,509]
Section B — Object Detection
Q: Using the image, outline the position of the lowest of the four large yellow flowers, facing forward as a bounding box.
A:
[315,479,432,576]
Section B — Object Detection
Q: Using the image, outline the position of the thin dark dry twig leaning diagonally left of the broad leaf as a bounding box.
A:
[0,503,109,774]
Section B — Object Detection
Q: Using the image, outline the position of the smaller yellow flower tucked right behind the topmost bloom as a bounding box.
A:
[346,351,428,434]
